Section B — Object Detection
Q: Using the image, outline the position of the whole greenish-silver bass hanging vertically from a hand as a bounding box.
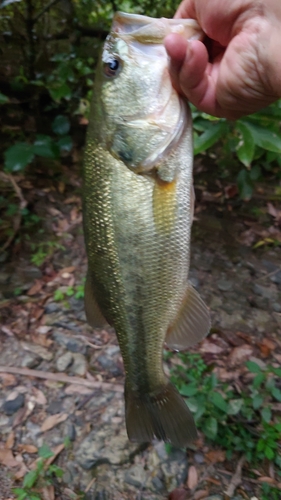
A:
[83,12,210,447]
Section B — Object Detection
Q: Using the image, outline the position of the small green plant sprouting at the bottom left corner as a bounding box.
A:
[13,444,63,500]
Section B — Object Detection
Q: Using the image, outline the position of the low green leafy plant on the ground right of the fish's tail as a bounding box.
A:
[168,353,281,468]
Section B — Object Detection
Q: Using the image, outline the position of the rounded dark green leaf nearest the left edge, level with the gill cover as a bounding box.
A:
[4,142,34,172]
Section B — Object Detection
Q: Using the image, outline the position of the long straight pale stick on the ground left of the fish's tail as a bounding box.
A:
[0,366,124,392]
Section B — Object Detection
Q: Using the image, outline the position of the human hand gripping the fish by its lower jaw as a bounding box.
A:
[165,0,281,119]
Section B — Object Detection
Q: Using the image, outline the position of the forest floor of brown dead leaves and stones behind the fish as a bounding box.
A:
[0,157,281,500]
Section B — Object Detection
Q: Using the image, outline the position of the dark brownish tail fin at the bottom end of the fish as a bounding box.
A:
[125,383,197,448]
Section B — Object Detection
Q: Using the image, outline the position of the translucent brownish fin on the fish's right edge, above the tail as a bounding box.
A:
[166,283,211,351]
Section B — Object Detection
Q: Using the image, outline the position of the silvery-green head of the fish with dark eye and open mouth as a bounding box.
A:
[93,12,201,173]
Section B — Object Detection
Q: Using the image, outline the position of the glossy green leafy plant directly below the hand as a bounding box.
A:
[191,100,281,200]
